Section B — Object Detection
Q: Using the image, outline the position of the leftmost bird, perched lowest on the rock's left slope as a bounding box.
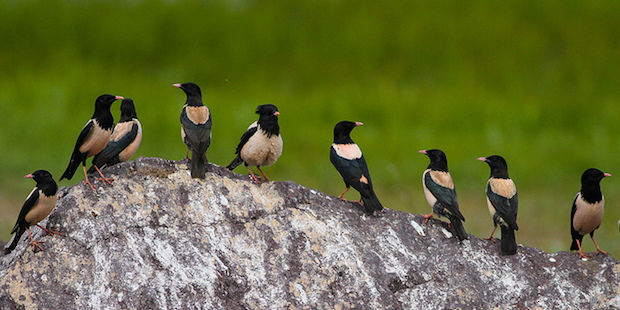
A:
[4,170,61,254]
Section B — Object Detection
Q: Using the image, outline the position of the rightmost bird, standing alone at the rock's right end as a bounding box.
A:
[570,168,611,259]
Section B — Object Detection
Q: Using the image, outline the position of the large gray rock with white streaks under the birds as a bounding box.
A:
[0,157,620,309]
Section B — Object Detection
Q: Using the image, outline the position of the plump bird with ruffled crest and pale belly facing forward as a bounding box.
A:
[226,104,282,183]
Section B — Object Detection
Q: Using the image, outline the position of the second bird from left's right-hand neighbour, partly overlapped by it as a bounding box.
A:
[88,98,142,174]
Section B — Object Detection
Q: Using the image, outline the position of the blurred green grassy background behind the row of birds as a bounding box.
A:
[0,0,620,258]
